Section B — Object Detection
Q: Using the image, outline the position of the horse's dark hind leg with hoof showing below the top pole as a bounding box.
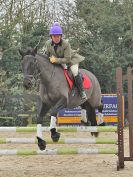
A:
[81,101,99,137]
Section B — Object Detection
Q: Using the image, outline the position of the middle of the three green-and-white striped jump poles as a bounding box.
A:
[0,138,117,144]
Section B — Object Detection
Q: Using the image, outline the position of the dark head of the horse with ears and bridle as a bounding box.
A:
[19,49,37,89]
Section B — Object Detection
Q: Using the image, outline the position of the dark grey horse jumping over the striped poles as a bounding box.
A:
[19,48,102,150]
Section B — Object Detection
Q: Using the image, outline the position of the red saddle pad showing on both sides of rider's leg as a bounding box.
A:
[63,69,92,90]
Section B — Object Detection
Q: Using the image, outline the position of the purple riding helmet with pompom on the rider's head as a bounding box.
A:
[49,22,63,35]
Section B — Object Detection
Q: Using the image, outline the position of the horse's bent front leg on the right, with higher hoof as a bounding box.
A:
[50,97,67,142]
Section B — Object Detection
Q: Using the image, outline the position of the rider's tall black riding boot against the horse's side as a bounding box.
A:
[75,73,87,101]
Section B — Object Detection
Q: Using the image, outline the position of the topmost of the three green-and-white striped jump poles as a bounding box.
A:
[0,126,117,132]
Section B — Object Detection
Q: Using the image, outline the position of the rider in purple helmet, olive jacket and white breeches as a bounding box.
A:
[45,22,87,100]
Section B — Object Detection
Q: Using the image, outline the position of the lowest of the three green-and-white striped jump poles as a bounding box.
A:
[0,148,118,155]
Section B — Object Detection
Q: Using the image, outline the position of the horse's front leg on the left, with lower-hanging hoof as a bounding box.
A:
[37,101,49,150]
